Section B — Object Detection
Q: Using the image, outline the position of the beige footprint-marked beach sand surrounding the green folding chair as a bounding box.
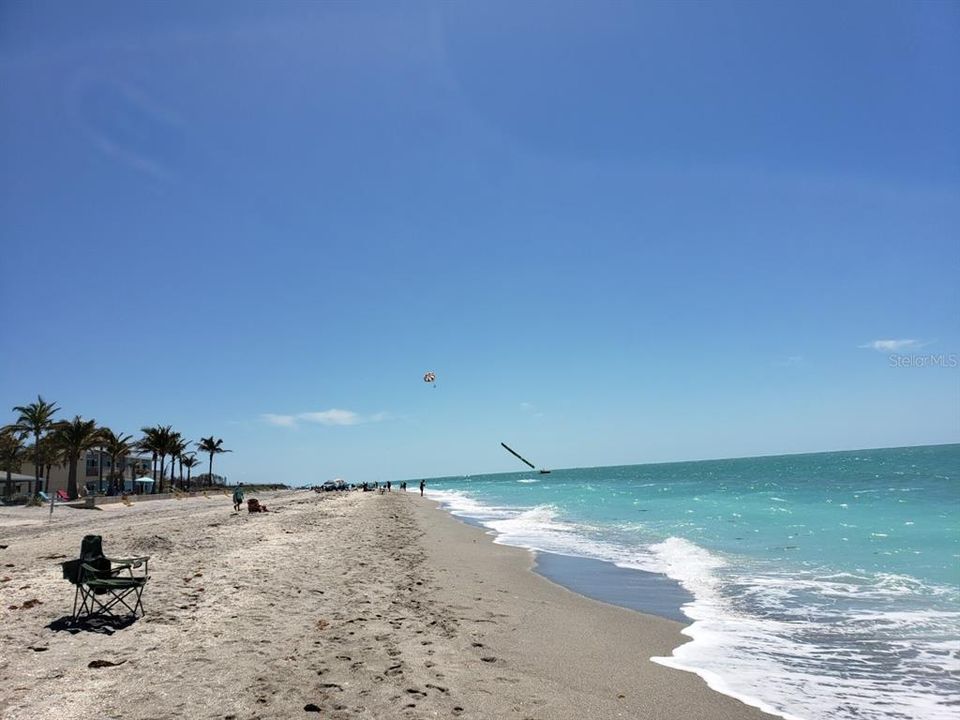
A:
[0,491,769,720]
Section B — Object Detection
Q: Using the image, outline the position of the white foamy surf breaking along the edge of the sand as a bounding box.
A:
[428,490,960,720]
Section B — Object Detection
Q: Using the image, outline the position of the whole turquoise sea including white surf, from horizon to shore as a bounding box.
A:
[428,445,960,720]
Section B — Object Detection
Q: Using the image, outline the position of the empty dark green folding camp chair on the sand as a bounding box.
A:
[60,535,150,625]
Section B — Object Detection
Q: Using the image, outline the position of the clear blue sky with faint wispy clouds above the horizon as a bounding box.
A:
[0,0,960,484]
